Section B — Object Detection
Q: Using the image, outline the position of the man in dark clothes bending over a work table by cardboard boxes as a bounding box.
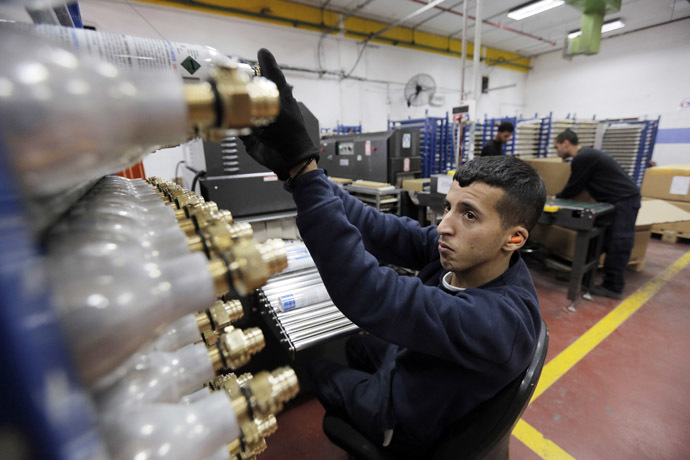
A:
[555,129,641,299]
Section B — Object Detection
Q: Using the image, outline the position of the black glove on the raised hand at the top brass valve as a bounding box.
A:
[240,48,319,180]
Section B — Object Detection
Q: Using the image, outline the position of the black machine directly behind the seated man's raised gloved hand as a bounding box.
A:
[199,102,323,217]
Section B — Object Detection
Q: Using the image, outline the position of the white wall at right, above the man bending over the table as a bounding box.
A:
[525,20,690,165]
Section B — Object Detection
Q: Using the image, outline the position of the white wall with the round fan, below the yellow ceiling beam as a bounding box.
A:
[79,0,526,131]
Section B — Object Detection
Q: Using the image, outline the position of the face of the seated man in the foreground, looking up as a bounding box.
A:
[437,180,510,273]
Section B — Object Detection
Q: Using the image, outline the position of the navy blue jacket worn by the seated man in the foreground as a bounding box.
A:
[292,170,540,445]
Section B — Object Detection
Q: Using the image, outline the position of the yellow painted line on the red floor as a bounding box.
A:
[513,251,690,460]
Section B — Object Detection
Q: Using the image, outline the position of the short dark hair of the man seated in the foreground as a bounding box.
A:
[453,155,546,231]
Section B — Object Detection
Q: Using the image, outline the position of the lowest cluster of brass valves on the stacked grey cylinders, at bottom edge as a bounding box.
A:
[209,367,299,460]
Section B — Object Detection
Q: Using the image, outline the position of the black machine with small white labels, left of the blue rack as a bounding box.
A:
[319,129,422,187]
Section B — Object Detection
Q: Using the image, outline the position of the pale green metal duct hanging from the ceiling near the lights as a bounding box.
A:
[565,0,621,55]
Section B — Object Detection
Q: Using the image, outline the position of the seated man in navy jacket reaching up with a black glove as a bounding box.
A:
[242,49,546,457]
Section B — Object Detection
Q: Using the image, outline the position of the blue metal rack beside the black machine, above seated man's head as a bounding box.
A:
[388,113,458,177]
